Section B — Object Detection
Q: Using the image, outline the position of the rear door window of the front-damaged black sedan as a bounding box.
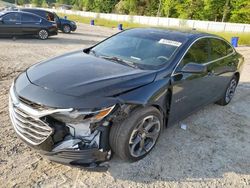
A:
[210,39,228,60]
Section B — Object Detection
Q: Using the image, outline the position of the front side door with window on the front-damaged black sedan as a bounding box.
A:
[169,38,212,123]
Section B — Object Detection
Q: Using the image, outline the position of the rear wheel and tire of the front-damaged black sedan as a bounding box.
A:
[216,75,238,106]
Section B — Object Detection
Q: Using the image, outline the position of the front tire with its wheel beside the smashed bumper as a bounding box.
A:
[109,107,163,162]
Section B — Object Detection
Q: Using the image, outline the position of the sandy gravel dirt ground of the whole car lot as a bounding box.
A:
[0,25,250,187]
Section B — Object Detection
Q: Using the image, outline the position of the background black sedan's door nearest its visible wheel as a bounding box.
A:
[21,13,41,35]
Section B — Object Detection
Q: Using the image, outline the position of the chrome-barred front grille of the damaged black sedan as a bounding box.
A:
[9,99,53,145]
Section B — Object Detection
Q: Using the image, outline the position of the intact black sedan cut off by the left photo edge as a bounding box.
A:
[0,11,57,40]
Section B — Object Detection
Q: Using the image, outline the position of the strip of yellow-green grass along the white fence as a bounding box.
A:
[58,13,250,45]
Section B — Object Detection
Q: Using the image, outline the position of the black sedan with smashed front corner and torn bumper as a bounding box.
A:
[9,28,244,167]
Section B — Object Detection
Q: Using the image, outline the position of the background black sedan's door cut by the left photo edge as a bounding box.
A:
[0,12,22,35]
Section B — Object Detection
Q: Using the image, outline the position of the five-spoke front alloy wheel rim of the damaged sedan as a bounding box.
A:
[129,115,161,157]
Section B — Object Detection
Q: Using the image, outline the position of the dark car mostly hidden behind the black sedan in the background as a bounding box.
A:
[20,8,77,33]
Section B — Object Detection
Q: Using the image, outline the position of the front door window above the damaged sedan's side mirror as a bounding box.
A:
[181,39,209,65]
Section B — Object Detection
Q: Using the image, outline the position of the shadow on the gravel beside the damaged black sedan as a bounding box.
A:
[105,83,250,183]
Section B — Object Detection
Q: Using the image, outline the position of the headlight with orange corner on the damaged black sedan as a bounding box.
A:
[51,105,115,123]
